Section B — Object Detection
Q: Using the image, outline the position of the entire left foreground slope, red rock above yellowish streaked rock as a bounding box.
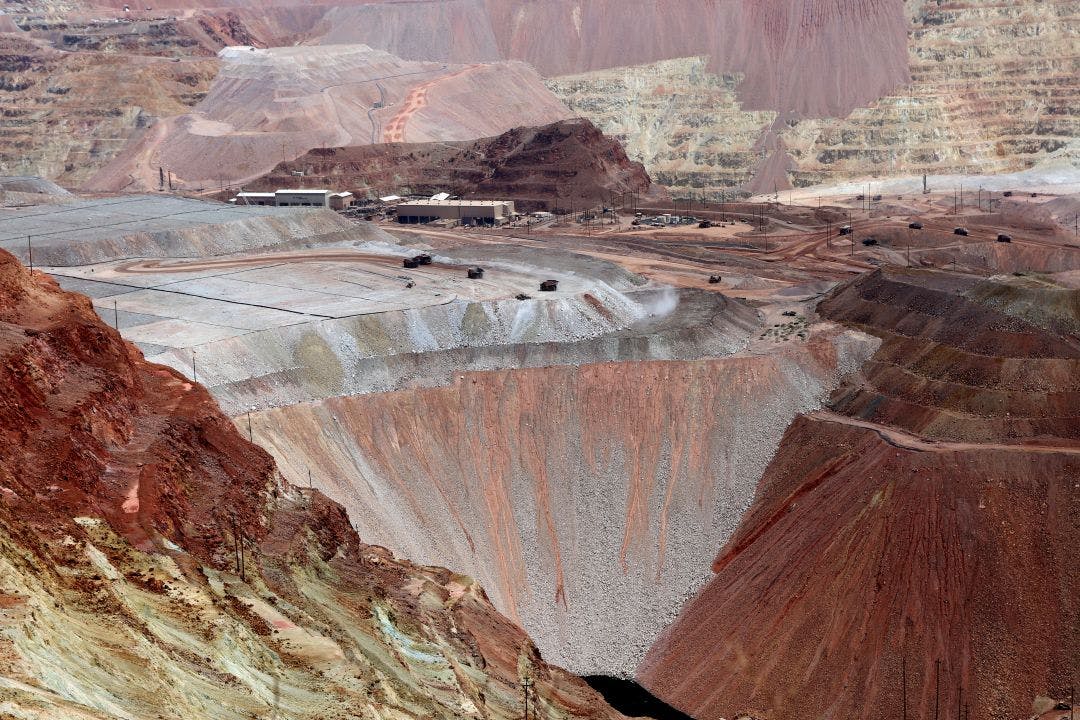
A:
[0,253,617,720]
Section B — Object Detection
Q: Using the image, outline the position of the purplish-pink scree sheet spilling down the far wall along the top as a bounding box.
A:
[311,0,908,116]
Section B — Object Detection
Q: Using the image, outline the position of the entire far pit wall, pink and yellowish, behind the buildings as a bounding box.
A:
[0,0,1080,194]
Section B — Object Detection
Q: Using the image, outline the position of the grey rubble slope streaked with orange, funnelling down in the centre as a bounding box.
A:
[247,317,873,675]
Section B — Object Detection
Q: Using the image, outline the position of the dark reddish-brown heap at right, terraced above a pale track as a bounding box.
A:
[639,271,1080,720]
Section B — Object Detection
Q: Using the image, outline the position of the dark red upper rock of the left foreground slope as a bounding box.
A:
[0,253,274,560]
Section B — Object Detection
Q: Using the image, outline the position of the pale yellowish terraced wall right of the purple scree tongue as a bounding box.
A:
[781,0,1080,185]
